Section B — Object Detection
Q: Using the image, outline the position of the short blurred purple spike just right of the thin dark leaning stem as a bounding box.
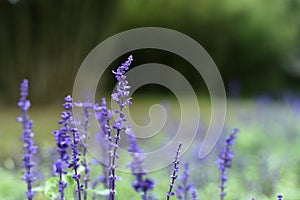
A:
[176,162,197,200]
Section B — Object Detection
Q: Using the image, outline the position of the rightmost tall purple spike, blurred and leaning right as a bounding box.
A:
[216,129,239,200]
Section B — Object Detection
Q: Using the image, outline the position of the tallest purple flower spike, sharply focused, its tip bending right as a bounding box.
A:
[109,56,133,200]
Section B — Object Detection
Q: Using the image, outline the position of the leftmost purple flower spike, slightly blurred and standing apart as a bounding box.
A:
[17,79,37,200]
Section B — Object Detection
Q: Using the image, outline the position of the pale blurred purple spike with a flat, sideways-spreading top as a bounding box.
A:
[74,100,94,200]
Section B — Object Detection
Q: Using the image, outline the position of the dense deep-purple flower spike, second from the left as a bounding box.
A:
[53,96,73,200]
